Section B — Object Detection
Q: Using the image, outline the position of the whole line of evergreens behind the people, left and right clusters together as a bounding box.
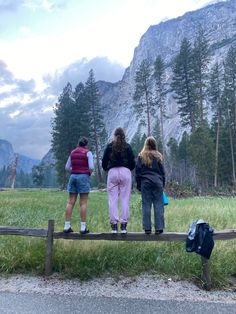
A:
[49,27,236,190]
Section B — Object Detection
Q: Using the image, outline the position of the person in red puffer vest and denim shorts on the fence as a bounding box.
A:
[64,137,94,234]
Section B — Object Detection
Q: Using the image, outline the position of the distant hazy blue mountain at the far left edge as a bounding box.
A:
[0,139,40,173]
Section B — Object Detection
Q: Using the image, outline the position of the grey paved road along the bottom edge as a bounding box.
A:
[0,292,236,314]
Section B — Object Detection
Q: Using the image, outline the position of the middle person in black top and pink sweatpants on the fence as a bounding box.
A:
[102,128,135,233]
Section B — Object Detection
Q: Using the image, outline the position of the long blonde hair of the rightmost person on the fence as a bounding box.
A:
[139,136,163,167]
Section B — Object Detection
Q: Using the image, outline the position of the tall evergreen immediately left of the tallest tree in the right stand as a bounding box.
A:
[171,38,198,132]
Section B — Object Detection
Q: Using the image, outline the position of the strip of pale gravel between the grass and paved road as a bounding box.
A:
[0,275,236,304]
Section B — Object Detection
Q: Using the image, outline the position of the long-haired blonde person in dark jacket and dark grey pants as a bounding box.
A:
[135,136,165,234]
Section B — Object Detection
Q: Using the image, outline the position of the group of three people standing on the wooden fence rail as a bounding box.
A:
[64,128,165,234]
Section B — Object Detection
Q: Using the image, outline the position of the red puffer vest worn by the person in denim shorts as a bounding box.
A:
[70,147,90,175]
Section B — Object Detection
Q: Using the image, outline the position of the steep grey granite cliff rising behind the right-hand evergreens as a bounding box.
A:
[98,0,236,140]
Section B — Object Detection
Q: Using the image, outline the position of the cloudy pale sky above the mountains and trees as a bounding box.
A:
[0,0,220,159]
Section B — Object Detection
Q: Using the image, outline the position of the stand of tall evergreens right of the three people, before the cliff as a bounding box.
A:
[133,27,236,190]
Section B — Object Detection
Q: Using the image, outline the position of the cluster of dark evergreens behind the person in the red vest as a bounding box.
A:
[52,70,107,188]
